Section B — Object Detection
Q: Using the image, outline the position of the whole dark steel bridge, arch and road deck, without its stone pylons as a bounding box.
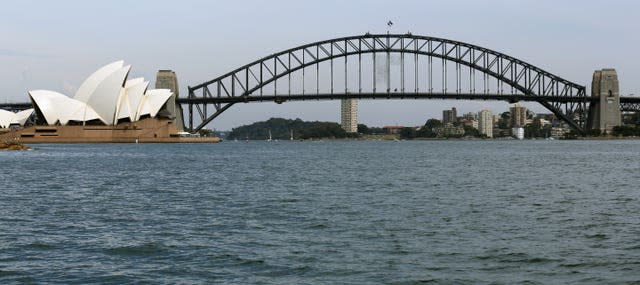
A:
[0,33,640,132]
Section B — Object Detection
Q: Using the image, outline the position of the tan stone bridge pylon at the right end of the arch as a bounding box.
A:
[588,68,622,132]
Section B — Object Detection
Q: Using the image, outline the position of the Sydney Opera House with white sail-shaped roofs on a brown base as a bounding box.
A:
[0,61,218,143]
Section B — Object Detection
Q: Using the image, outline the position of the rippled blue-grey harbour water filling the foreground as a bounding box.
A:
[0,141,640,284]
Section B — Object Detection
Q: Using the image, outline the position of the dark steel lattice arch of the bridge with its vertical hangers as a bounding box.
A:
[182,33,592,131]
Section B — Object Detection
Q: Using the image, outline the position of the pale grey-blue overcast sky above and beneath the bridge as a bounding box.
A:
[0,0,640,130]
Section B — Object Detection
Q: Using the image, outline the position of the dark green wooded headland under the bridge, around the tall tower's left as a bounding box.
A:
[227,118,357,140]
